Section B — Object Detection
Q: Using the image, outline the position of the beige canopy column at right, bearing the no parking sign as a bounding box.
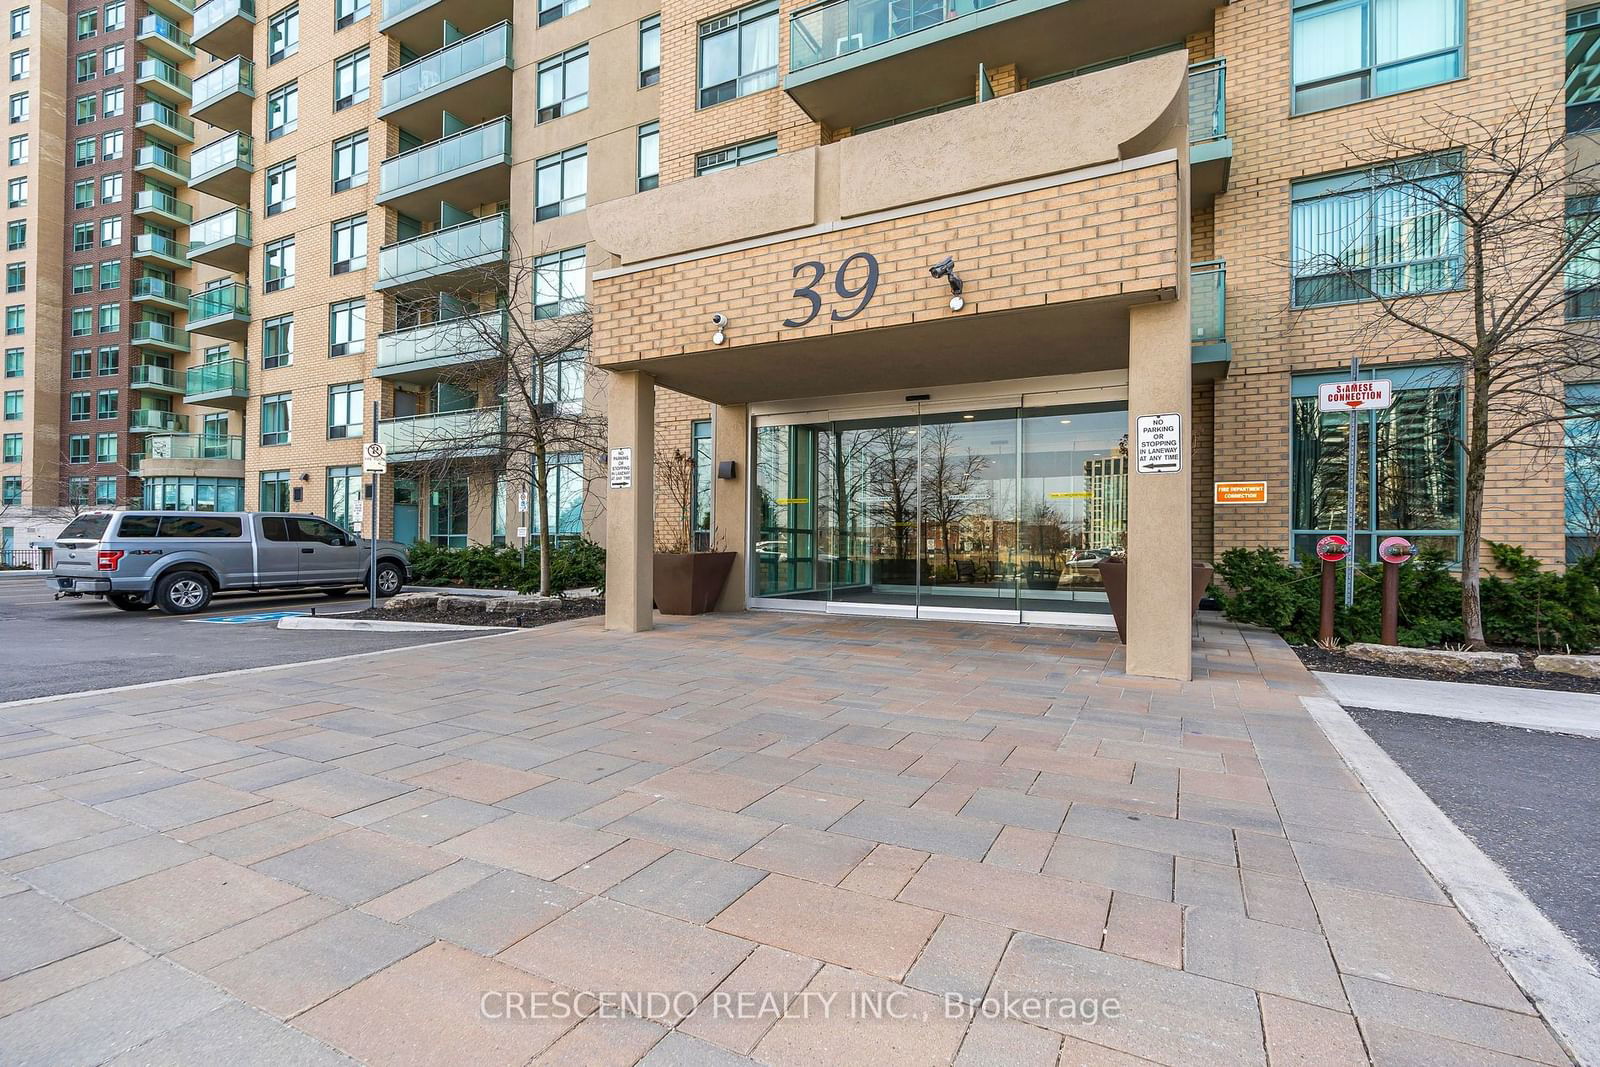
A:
[1128,299,1194,681]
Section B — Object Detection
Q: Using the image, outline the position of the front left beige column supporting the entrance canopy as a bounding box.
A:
[605,371,656,632]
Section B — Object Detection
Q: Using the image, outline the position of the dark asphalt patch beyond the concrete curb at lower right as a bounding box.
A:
[1347,707,1600,958]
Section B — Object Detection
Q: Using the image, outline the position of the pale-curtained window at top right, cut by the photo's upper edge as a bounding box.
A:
[1293,0,1462,114]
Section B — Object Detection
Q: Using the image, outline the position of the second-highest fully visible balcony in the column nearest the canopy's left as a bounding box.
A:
[378,117,510,218]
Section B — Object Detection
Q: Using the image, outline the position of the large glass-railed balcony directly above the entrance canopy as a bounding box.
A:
[782,0,1216,130]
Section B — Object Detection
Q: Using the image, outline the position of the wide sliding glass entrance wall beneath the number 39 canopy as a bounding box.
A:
[750,403,1128,621]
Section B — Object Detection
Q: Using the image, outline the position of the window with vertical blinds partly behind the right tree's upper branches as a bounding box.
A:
[1290,157,1464,307]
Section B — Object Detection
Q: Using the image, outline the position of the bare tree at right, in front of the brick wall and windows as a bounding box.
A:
[1294,99,1600,648]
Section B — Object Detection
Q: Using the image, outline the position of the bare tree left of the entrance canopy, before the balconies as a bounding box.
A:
[384,248,606,595]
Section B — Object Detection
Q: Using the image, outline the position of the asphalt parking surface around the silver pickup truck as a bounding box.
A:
[0,577,505,701]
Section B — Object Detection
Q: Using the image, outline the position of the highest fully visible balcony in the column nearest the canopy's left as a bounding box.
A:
[378,22,512,138]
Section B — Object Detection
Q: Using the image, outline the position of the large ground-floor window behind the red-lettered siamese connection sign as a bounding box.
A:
[1290,366,1462,561]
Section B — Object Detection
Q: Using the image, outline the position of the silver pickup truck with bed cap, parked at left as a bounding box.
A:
[51,510,408,614]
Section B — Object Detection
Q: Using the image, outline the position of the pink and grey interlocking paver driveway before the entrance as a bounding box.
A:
[0,614,1570,1067]
